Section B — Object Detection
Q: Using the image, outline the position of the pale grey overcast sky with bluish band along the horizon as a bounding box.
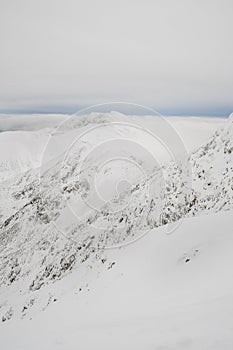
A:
[0,0,233,115]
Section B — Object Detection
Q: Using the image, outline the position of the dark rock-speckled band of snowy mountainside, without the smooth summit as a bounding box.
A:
[0,113,233,319]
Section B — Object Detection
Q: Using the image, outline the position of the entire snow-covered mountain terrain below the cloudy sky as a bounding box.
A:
[0,112,233,350]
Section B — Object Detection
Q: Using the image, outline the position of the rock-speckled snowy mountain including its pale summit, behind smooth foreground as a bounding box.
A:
[0,115,233,321]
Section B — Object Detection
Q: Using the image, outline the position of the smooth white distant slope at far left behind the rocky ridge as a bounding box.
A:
[0,114,67,182]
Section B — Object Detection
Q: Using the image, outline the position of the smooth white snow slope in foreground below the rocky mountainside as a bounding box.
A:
[0,211,233,350]
